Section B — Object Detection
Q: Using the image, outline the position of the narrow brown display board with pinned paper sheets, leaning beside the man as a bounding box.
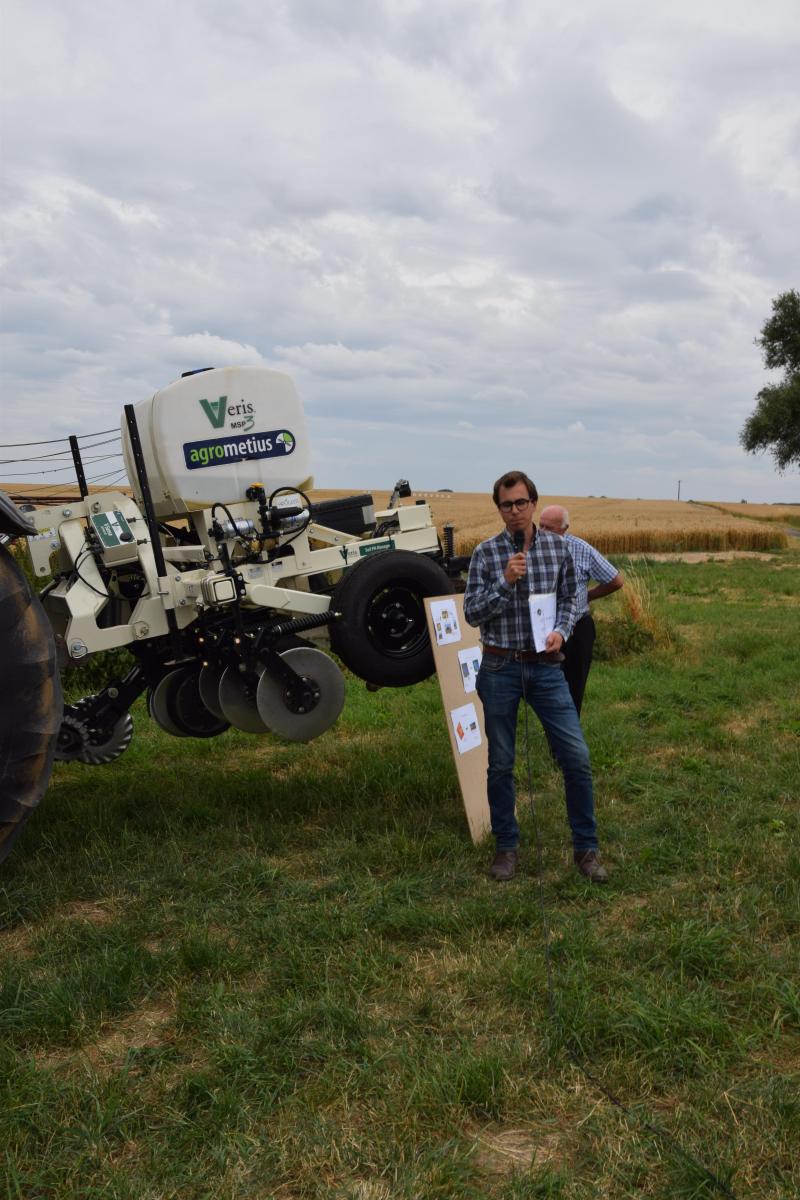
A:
[425,595,489,842]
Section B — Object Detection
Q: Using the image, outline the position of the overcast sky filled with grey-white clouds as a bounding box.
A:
[0,0,800,502]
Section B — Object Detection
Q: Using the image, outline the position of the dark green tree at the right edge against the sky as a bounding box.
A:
[739,289,800,470]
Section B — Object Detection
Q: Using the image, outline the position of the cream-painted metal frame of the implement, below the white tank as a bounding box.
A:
[28,491,440,662]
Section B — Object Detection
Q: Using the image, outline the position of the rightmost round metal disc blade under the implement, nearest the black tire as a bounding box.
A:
[258,646,344,742]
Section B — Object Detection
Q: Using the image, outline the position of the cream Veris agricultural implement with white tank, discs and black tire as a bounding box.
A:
[17,367,464,764]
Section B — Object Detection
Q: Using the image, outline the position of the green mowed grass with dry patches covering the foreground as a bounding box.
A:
[0,553,800,1200]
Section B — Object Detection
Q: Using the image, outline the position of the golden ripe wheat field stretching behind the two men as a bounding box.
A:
[312,490,798,554]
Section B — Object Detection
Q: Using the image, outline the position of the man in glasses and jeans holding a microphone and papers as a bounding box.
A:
[464,470,608,883]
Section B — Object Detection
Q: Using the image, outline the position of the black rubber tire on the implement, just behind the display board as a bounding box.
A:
[331,550,452,688]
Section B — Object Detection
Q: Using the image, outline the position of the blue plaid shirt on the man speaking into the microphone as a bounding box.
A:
[464,529,577,650]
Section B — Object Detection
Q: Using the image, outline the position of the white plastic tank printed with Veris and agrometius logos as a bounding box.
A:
[122,367,313,517]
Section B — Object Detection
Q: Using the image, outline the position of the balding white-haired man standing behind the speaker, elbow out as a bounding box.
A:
[539,504,625,714]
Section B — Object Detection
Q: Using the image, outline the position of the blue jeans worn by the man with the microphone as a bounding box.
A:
[477,654,597,850]
